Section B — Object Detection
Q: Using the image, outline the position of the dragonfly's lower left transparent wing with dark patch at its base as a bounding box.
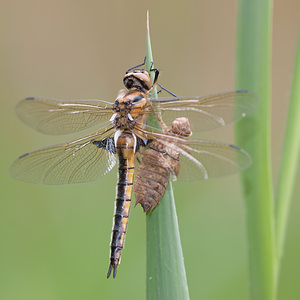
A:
[10,130,116,184]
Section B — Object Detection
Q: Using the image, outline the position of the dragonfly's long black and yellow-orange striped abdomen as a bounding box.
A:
[107,132,136,278]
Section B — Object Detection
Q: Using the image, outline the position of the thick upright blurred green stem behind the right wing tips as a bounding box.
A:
[236,0,276,300]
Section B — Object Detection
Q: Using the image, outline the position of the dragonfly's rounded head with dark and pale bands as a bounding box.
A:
[123,70,153,93]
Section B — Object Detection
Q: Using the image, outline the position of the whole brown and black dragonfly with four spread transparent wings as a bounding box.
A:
[10,64,257,278]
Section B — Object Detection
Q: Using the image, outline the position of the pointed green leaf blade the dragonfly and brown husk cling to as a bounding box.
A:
[146,11,189,300]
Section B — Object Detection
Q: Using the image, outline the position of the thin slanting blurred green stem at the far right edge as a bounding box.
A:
[275,24,300,265]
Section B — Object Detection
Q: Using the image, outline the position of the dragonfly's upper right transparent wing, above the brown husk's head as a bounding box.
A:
[147,90,258,132]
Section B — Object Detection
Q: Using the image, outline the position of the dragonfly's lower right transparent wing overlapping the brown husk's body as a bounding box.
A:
[144,133,251,181]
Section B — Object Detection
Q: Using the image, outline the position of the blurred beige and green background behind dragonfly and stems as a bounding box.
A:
[0,0,300,300]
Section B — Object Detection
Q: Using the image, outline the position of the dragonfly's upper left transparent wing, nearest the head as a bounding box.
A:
[16,97,112,134]
